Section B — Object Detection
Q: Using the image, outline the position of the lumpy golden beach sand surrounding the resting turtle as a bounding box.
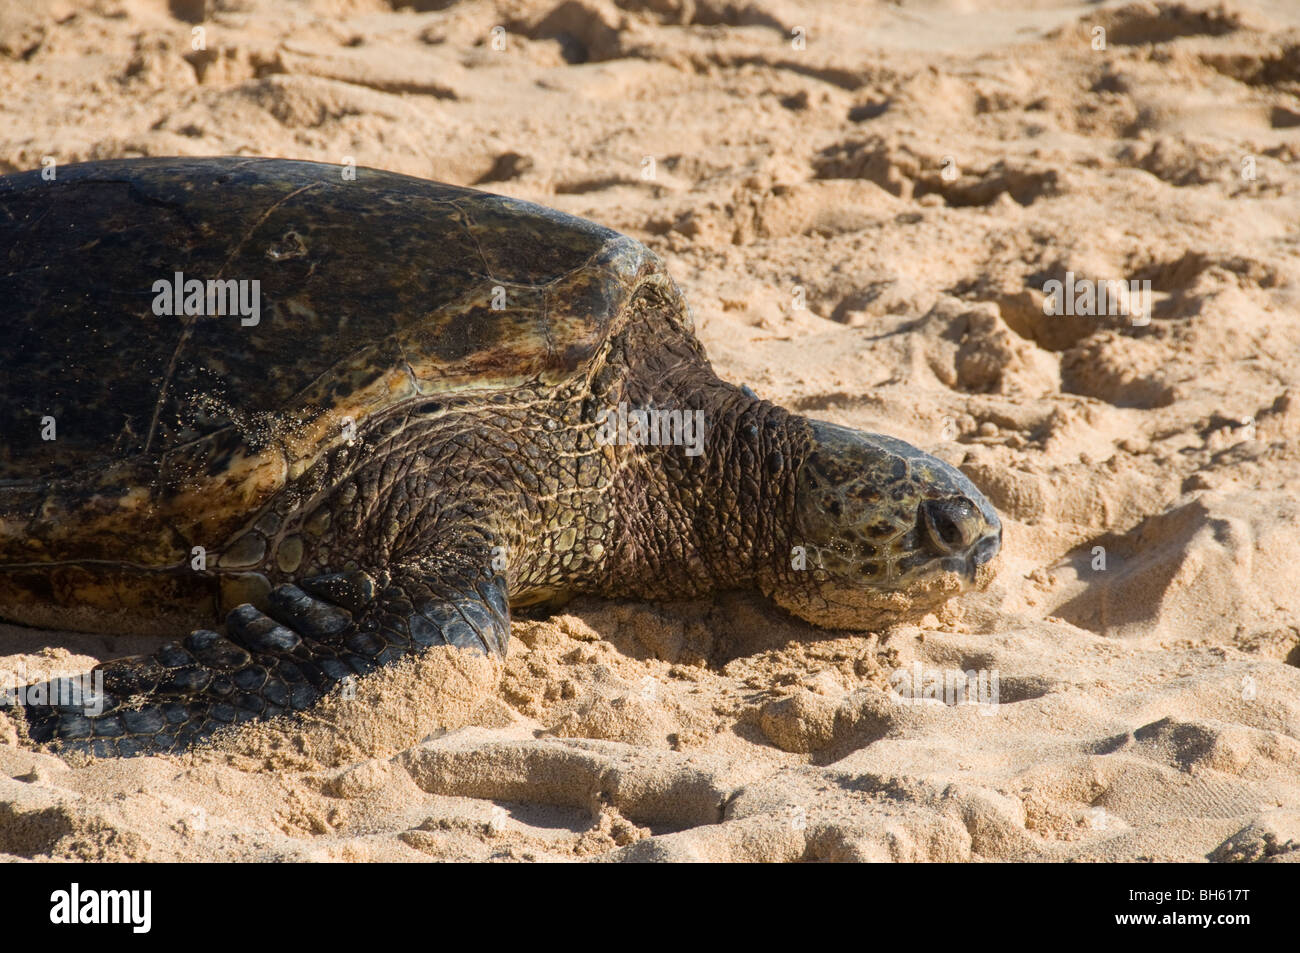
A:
[0,0,1300,861]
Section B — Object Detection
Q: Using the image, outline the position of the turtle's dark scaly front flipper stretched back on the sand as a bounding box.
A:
[10,554,510,757]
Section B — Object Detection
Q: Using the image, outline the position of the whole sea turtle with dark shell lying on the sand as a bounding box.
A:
[0,157,1002,755]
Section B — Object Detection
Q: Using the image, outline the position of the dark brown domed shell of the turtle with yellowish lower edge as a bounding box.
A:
[0,159,689,616]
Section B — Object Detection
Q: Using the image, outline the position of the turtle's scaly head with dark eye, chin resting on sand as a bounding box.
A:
[763,420,1002,629]
